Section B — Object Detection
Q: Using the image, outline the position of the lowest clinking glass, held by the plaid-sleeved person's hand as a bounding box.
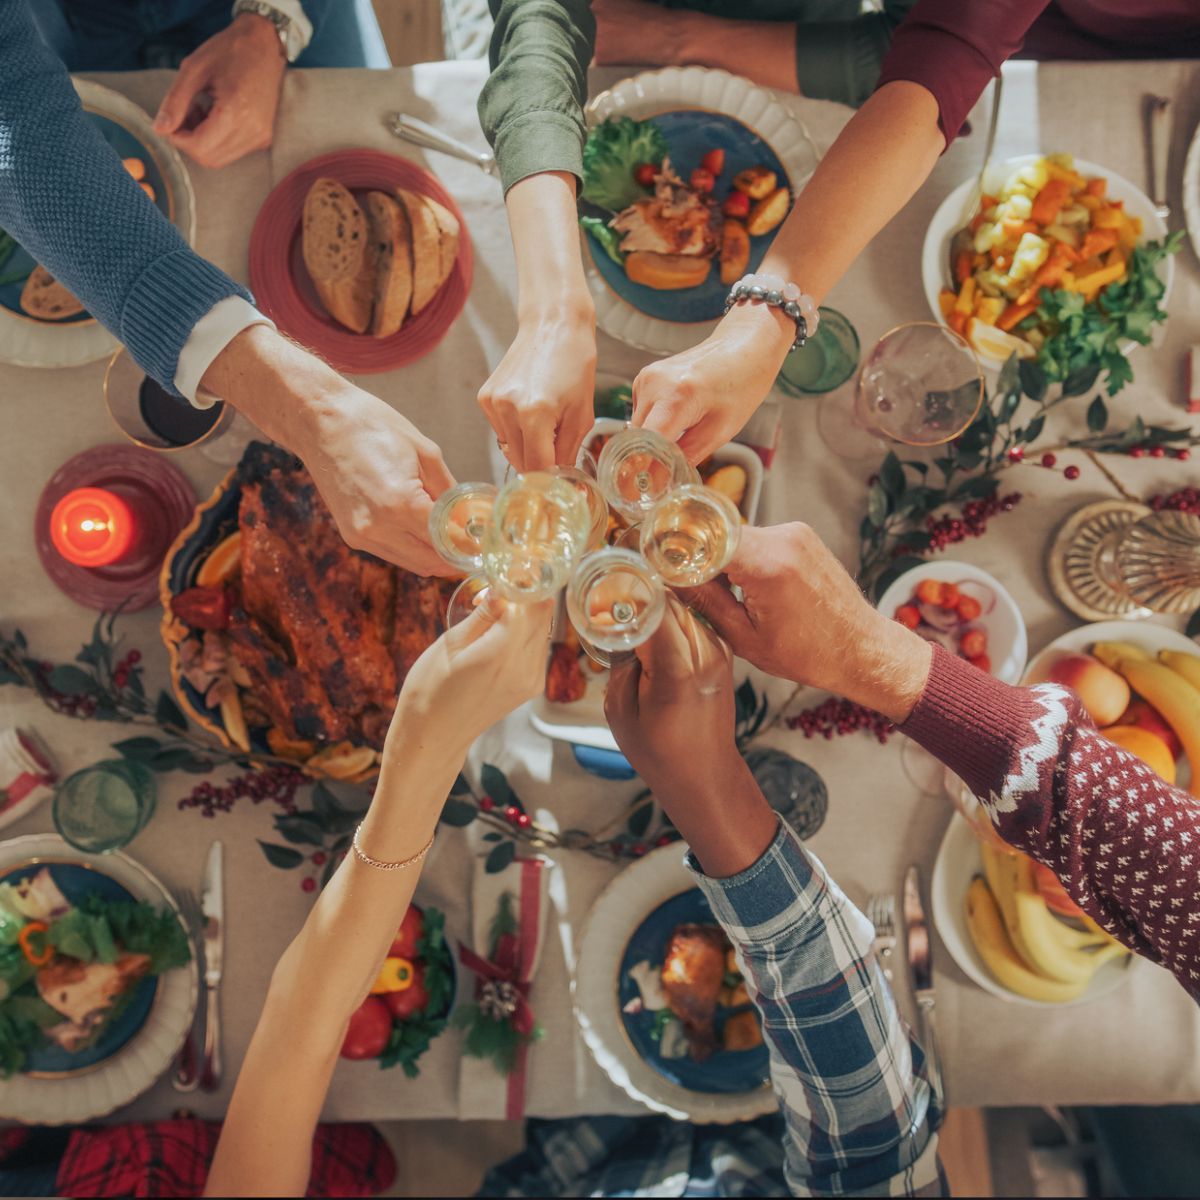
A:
[566,546,666,667]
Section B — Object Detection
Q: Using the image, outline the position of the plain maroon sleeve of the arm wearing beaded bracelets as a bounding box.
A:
[876,0,1050,145]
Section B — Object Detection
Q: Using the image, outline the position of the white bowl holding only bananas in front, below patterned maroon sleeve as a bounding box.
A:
[929,812,1139,1008]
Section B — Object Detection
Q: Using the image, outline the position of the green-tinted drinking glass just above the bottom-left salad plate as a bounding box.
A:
[53,758,156,854]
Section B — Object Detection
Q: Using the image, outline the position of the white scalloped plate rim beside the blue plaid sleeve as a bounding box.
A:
[571,845,779,1124]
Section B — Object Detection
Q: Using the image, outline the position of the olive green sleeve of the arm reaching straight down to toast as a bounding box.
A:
[479,0,595,192]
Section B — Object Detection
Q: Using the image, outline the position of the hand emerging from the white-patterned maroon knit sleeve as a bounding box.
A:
[688,522,932,721]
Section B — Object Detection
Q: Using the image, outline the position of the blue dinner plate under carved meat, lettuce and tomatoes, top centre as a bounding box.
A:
[588,109,791,324]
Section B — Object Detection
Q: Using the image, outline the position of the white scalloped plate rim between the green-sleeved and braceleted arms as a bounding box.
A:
[580,67,821,354]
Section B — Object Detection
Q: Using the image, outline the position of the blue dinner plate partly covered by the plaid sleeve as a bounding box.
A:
[618,888,768,1093]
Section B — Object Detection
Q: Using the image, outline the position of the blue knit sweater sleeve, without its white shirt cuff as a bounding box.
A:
[0,0,251,395]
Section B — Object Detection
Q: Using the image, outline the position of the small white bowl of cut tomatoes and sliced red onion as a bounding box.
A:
[878,560,1028,683]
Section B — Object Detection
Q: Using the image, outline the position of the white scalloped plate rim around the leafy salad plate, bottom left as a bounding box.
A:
[0,834,199,1124]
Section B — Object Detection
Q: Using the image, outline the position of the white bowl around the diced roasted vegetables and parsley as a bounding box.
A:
[920,154,1175,370]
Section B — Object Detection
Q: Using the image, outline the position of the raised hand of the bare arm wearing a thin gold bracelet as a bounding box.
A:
[398,589,554,752]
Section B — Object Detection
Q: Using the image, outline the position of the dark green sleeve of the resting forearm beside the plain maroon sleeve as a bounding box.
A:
[796,0,916,108]
